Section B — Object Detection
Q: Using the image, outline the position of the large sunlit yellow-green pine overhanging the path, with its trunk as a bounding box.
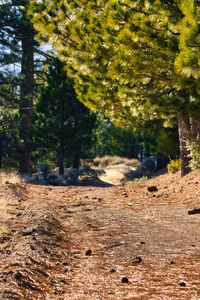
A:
[30,0,200,175]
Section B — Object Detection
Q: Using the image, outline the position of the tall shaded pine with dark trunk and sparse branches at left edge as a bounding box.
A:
[0,0,50,175]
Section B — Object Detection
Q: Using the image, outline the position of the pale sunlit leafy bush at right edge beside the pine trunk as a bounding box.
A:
[187,141,200,172]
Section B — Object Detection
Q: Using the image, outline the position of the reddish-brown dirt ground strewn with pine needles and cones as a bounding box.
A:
[0,172,200,300]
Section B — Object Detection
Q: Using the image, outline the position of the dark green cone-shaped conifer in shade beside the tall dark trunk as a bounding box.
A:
[32,58,96,174]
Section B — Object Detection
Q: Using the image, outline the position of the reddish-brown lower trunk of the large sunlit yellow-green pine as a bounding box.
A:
[178,116,191,176]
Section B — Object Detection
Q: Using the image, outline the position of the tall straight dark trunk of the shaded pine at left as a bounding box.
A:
[19,11,34,175]
